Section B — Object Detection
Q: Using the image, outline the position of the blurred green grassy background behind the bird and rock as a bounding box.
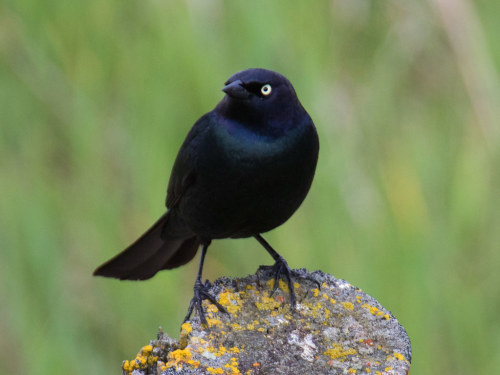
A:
[0,0,500,375]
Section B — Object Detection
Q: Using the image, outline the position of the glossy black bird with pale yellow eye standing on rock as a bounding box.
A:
[94,69,319,324]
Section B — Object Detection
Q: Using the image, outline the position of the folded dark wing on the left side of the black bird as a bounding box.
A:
[165,113,210,208]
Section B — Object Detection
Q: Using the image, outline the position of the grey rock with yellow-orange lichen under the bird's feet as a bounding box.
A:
[122,268,411,375]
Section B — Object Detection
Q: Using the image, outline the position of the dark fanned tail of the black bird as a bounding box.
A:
[94,211,200,280]
